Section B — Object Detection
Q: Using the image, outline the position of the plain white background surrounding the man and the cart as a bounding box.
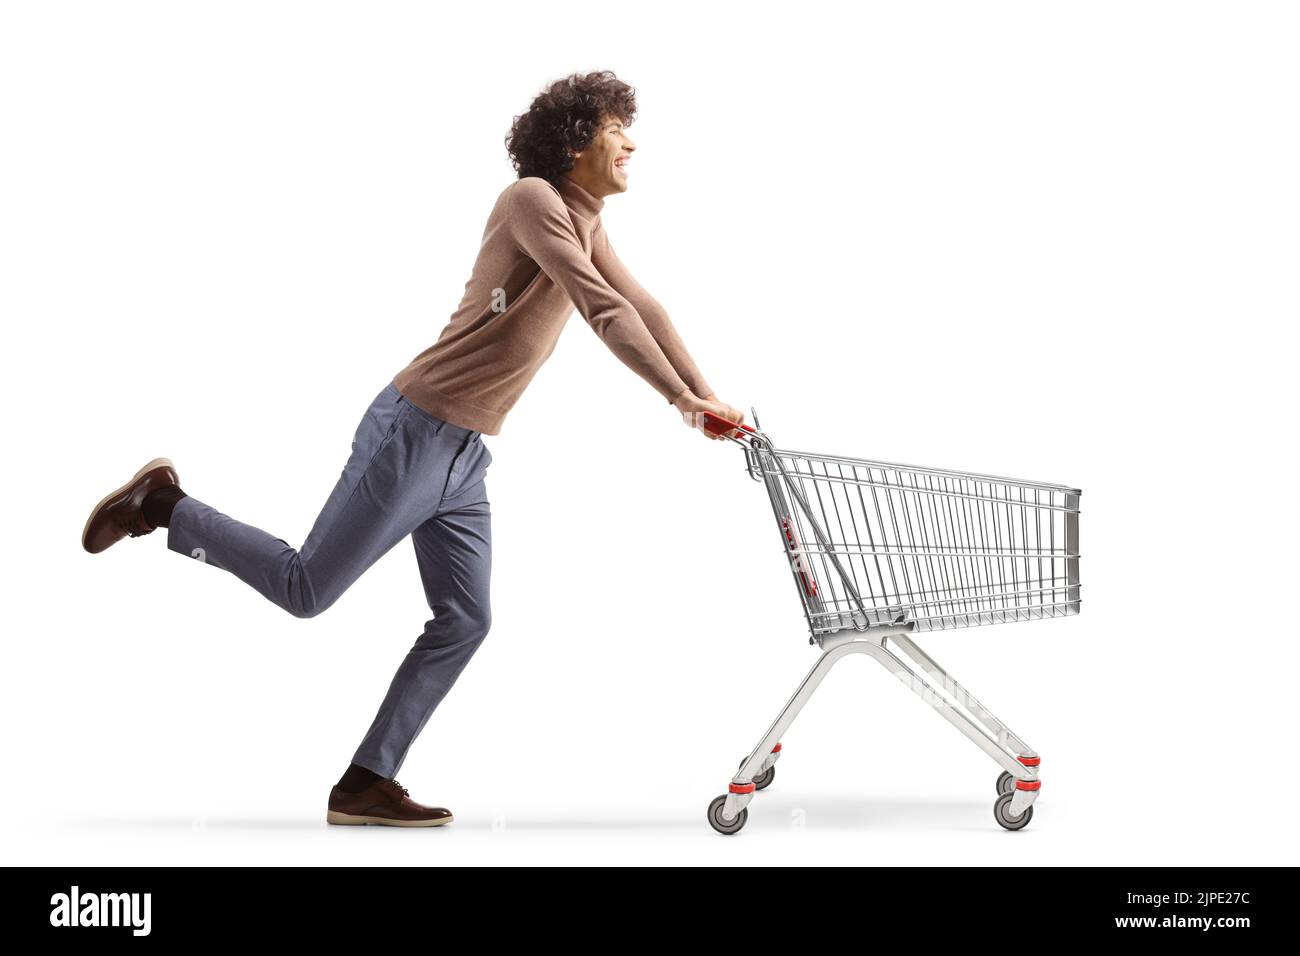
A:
[0,3,1300,866]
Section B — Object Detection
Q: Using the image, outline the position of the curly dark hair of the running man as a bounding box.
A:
[506,70,637,186]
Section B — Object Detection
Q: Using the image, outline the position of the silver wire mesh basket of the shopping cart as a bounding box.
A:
[746,440,1080,637]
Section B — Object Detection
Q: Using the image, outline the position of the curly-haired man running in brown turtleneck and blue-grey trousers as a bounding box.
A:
[82,72,744,827]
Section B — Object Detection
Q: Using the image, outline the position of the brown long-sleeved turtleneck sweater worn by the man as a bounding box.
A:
[394,177,712,434]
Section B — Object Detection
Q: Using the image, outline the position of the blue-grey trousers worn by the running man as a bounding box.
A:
[168,384,491,778]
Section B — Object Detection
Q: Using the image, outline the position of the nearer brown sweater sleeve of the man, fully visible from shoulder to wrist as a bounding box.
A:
[506,177,690,405]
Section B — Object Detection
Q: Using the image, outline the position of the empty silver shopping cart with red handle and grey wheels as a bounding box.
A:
[701,410,1080,834]
